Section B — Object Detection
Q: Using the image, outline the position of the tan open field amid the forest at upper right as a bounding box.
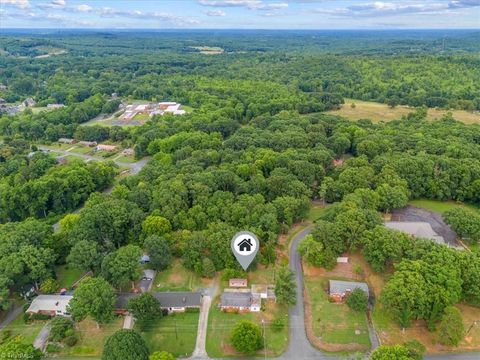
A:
[330,99,480,124]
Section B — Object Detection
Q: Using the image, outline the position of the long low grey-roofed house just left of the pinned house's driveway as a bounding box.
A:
[115,291,202,314]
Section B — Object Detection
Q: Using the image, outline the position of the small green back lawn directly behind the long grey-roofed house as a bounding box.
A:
[152,260,202,291]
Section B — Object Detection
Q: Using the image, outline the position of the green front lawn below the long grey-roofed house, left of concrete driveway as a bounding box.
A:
[137,312,200,357]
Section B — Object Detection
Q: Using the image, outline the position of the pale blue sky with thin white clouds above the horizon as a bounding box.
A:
[0,0,480,29]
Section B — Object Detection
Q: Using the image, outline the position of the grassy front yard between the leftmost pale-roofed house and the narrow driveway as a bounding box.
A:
[59,316,123,357]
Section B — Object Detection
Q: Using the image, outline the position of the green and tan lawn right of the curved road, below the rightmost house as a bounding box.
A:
[305,277,370,350]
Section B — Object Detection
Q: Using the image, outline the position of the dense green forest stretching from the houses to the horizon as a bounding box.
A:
[0,28,480,344]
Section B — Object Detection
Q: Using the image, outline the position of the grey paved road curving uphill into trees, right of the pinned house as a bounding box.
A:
[284,226,480,360]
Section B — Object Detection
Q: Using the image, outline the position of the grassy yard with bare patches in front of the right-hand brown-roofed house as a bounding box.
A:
[304,276,370,351]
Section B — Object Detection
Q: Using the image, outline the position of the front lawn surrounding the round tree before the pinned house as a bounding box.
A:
[206,302,288,358]
